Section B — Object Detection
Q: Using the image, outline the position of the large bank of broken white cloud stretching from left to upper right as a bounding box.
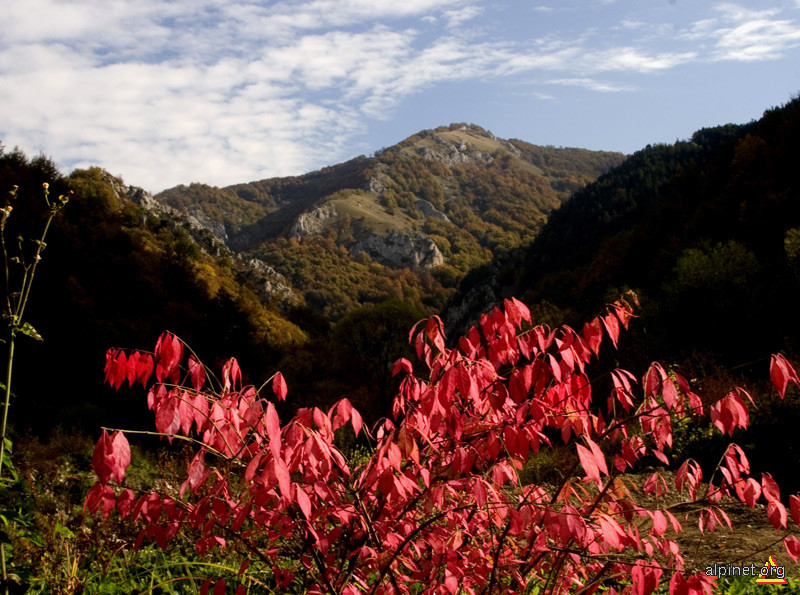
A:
[0,0,800,190]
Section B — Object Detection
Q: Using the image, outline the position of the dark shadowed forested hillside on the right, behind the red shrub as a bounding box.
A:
[444,99,800,494]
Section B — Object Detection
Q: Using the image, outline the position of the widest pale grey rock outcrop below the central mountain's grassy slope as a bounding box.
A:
[350,231,444,271]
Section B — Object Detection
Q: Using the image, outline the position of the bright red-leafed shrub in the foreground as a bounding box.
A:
[86,295,800,595]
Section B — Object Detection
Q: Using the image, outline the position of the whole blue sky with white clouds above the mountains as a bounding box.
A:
[0,0,800,193]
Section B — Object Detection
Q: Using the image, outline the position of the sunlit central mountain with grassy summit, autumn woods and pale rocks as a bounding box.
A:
[156,124,623,320]
